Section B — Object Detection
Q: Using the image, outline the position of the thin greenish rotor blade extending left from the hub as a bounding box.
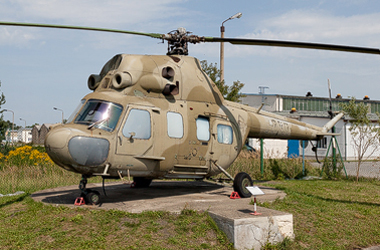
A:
[0,22,162,39]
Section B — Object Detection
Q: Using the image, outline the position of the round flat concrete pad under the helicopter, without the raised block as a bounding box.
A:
[32,180,285,216]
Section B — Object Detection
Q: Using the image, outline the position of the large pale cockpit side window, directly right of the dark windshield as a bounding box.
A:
[123,109,151,139]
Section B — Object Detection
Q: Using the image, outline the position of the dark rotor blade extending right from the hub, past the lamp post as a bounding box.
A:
[205,37,380,55]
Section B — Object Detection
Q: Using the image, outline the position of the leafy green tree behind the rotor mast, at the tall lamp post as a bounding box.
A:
[201,60,245,102]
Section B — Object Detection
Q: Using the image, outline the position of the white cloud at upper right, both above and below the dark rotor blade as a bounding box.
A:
[221,10,380,58]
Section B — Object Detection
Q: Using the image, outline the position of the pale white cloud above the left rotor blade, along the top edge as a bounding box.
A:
[0,0,183,28]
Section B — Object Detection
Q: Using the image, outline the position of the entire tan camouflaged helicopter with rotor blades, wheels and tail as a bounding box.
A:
[0,22,380,204]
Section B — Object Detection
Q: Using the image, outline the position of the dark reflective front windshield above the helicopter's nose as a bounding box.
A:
[74,100,123,132]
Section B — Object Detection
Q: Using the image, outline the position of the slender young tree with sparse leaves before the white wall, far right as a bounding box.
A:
[342,98,380,181]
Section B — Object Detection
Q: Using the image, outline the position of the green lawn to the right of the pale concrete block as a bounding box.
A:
[259,179,380,249]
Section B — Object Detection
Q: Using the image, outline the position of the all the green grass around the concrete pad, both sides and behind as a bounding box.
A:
[0,147,380,249]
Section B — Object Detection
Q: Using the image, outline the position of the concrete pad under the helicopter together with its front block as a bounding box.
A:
[32,181,294,249]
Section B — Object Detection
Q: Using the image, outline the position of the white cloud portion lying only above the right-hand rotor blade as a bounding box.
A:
[246,10,380,45]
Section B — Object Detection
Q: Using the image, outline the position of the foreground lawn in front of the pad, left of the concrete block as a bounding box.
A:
[0,195,233,249]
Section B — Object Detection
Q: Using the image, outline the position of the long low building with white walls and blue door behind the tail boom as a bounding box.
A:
[241,92,380,160]
